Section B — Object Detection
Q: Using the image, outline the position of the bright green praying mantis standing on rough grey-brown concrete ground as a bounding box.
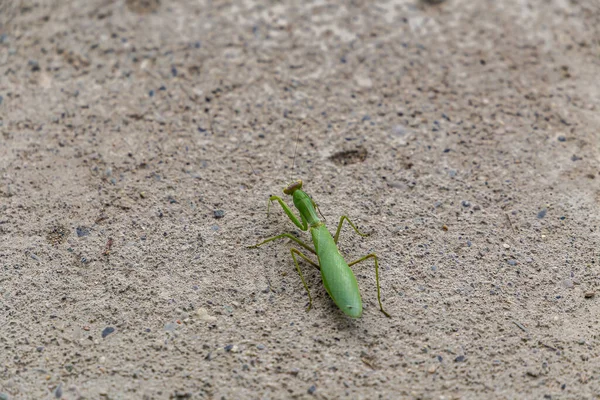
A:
[250,180,391,318]
